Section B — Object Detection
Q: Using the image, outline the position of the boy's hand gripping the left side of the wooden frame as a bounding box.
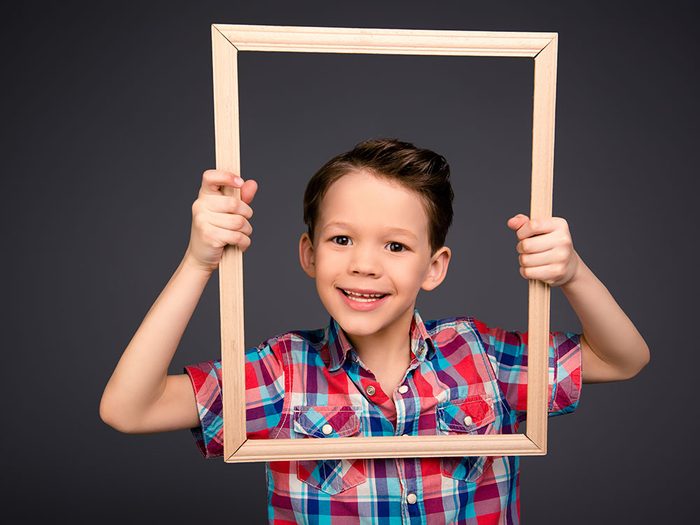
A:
[185,169,258,272]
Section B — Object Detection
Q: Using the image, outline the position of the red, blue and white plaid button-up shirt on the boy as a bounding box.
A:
[184,309,581,525]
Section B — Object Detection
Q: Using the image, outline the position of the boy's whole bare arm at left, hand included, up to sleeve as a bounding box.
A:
[100,169,258,433]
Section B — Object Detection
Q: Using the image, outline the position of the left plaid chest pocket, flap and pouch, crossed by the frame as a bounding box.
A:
[293,405,367,495]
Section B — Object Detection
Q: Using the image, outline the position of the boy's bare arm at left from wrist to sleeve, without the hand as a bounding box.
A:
[100,253,212,433]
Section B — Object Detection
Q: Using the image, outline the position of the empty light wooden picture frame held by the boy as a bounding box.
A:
[211,24,557,463]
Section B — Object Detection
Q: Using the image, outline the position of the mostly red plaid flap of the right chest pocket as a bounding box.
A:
[437,394,496,434]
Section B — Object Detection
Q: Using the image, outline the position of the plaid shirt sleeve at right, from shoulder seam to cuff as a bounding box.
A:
[471,318,582,422]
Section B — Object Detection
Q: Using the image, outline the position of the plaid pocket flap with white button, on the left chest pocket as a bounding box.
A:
[294,405,360,437]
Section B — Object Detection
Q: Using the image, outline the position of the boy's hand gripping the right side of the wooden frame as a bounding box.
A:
[507,213,579,286]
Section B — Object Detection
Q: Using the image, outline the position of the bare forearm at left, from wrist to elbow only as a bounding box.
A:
[100,254,211,426]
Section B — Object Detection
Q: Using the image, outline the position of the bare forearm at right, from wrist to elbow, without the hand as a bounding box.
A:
[561,254,649,375]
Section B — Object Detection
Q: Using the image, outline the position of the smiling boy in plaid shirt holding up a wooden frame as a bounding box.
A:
[100,139,649,525]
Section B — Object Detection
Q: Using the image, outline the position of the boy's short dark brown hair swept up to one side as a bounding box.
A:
[304,138,454,255]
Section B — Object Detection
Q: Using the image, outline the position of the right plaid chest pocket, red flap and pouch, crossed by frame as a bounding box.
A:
[437,394,497,483]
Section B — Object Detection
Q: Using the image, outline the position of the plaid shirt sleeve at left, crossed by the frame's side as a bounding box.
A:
[184,342,284,459]
